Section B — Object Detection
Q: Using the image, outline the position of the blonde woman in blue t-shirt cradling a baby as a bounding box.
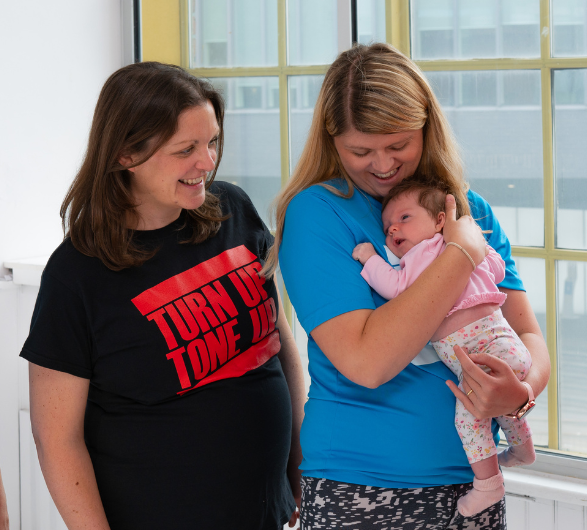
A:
[274,44,550,530]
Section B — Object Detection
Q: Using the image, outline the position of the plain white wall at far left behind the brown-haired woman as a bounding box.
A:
[0,0,127,529]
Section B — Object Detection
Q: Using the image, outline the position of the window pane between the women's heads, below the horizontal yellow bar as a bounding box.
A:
[288,75,324,171]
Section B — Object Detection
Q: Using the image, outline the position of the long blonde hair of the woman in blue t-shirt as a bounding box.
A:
[263,43,467,275]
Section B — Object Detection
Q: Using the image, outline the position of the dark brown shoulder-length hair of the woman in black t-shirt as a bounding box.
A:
[60,62,225,271]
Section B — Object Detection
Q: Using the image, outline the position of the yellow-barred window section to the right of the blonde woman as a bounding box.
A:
[410,0,587,454]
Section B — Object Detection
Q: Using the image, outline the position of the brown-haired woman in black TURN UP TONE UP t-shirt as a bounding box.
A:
[21,63,303,530]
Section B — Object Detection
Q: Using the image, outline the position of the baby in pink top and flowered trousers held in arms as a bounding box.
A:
[353,177,536,517]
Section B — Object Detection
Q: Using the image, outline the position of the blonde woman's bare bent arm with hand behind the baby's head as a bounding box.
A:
[310,195,485,388]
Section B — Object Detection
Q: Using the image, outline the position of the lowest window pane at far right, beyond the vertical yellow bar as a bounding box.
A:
[557,261,587,453]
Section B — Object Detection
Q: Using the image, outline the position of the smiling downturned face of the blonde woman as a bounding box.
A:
[334,129,424,201]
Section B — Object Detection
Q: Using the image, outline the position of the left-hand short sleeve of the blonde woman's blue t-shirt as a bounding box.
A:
[279,190,375,334]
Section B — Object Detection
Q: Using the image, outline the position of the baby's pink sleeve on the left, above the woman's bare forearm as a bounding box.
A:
[361,239,436,300]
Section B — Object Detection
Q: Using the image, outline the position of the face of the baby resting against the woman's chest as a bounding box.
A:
[381,191,445,258]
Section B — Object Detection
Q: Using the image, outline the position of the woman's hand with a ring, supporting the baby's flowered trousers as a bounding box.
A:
[446,346,528,419]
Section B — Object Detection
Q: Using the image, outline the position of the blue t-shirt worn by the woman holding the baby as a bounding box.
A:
[279,179,524,488]
